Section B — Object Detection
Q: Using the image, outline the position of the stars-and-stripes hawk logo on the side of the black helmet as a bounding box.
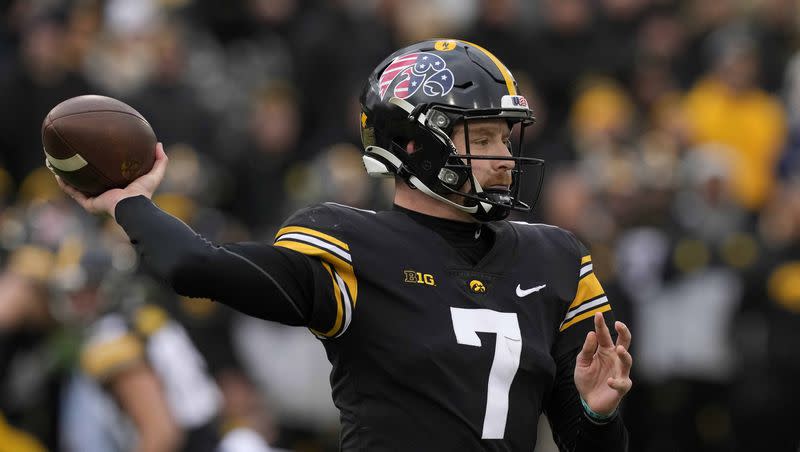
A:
[379,52,455,99]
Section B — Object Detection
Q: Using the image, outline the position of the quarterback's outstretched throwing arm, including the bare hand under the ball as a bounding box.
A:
[56,143,344,336]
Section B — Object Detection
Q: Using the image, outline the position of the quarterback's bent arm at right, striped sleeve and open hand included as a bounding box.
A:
[546,234,632,452]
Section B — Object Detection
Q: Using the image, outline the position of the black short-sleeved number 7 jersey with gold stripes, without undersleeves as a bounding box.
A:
[275,203,611,451]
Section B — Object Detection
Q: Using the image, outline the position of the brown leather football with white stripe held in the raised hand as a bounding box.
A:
[42,95,156,196]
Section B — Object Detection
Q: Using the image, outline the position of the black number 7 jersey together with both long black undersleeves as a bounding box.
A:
[116,197,627,452]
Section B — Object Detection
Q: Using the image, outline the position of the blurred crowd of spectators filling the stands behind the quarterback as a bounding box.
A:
[0,0,800,452]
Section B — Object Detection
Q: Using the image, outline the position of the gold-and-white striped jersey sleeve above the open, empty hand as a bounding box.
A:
[554,233,616,357]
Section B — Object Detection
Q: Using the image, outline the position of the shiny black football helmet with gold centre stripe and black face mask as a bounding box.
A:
[361,39,544,221]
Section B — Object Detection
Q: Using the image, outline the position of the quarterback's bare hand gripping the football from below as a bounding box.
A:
[56,143,169,217]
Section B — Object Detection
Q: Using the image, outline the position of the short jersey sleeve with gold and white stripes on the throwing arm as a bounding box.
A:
[274,205,358,338]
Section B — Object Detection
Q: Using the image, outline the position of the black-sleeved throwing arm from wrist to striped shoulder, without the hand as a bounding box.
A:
[115,196,355,337]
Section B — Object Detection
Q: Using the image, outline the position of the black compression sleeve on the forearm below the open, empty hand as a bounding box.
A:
[545,348,628,452]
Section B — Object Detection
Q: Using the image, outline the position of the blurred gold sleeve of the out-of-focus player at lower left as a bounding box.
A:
[80,315,145,382]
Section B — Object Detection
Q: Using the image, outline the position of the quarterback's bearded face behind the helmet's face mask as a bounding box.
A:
[453,119,514,190]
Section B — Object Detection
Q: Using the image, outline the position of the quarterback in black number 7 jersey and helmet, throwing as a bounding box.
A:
[60,39,632,452]
